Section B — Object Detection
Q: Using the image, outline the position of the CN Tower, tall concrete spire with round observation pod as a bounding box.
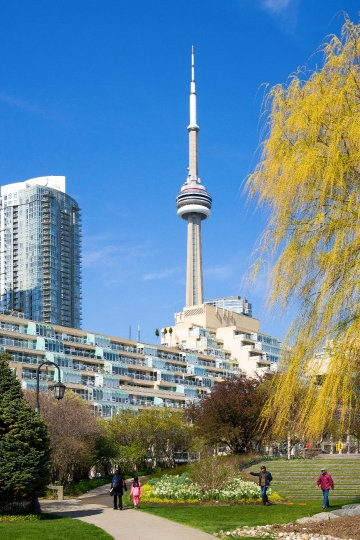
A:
[176,47,212,307]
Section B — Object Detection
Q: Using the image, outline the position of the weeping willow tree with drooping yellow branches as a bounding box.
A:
[247,17,360,439]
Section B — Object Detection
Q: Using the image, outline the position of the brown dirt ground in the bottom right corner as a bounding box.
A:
[273,515,360,540]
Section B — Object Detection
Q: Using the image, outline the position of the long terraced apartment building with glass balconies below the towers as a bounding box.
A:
[0,310,241,417]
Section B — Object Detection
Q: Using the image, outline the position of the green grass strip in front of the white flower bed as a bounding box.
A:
[138,497,351,534]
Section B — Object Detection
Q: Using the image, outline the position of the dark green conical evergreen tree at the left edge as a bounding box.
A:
[0,354,50,501]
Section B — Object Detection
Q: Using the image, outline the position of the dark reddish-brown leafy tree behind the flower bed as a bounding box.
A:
[187,375,269,454]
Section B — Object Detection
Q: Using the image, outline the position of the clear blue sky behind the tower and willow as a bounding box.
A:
[0,0,359,342]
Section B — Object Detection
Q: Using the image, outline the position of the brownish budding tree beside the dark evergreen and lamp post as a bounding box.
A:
[26,392,102,485]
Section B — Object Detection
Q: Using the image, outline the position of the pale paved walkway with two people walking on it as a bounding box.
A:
[41,495,214,540]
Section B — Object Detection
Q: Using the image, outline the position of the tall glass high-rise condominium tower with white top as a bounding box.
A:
[0,176,81,328]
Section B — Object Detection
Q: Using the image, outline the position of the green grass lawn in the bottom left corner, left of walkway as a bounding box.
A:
[0,516,113,540]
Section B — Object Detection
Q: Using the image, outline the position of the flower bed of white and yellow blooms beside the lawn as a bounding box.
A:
[141,473,280,504]
